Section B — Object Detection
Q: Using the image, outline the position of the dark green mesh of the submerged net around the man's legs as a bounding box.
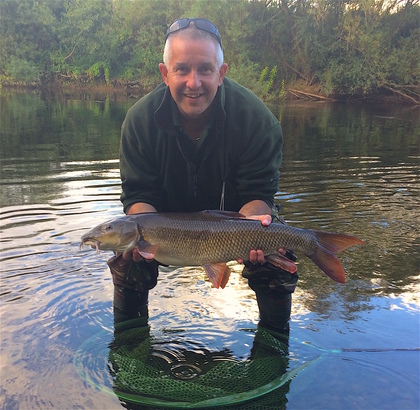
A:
[109,327,307,409]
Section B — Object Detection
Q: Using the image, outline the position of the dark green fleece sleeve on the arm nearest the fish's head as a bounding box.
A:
[120,106,161,213]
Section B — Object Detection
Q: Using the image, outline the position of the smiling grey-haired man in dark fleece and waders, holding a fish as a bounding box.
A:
[109,18,297,329]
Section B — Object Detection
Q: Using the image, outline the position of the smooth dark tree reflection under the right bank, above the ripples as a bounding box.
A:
[273,103,420,166]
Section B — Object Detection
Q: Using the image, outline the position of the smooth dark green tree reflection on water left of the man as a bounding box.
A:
[0,94,126,205]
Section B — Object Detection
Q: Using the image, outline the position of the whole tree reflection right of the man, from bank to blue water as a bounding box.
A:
[277,105,420,315]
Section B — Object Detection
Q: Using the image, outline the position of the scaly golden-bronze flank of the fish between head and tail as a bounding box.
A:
[137,214,317,264]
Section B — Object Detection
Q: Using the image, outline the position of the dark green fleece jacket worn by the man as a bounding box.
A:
[120,78,283,212]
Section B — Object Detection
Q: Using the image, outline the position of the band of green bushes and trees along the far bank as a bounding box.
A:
[0,0,420,99]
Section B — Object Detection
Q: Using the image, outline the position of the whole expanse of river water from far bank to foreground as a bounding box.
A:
[0,92,420,410]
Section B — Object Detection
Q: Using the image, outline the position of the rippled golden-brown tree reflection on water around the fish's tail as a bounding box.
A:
[279,156,419,314]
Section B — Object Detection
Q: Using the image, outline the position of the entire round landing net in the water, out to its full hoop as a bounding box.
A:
[73,322,322,410]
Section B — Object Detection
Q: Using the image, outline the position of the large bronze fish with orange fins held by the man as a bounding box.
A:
[80,210,364,288]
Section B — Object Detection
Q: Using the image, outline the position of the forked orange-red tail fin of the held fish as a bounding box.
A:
[309,231,364,283]
